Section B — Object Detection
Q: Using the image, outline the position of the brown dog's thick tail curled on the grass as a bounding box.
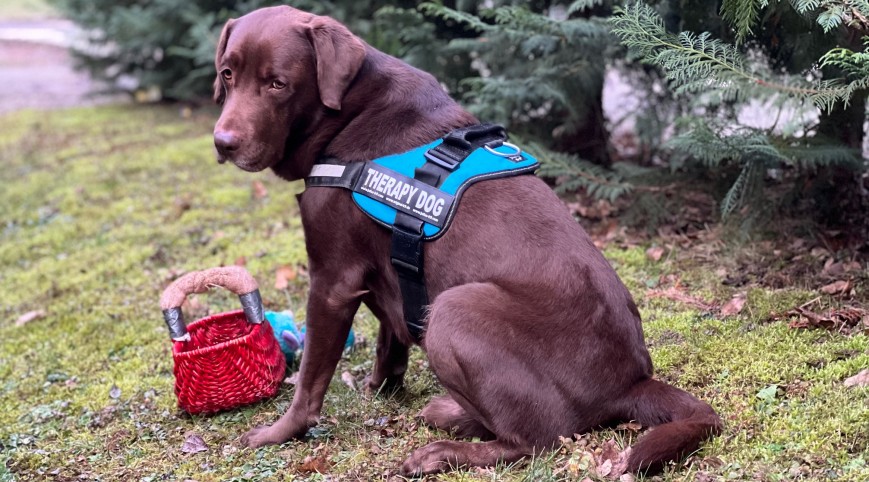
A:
[627,379,721,473]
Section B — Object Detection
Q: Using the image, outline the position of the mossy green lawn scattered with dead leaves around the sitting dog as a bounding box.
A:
[0,107,869,482]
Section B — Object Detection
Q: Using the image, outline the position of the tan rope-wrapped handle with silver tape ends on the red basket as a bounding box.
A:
[160,266,265,341]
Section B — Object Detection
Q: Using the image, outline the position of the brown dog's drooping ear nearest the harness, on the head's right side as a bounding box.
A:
[307,16,365,110]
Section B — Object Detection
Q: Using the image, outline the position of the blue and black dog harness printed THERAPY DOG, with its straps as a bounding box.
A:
[305,124,540,342]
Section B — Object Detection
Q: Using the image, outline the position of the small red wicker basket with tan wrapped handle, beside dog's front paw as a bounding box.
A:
[160,266,286,413]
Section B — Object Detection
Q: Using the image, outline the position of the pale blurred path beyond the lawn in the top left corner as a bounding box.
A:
[0,20,118,114]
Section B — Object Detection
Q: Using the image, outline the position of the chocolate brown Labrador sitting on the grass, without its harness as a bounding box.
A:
[214,6,721,474]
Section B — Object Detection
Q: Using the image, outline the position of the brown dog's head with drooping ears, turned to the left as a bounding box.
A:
[214,6,365,171]
